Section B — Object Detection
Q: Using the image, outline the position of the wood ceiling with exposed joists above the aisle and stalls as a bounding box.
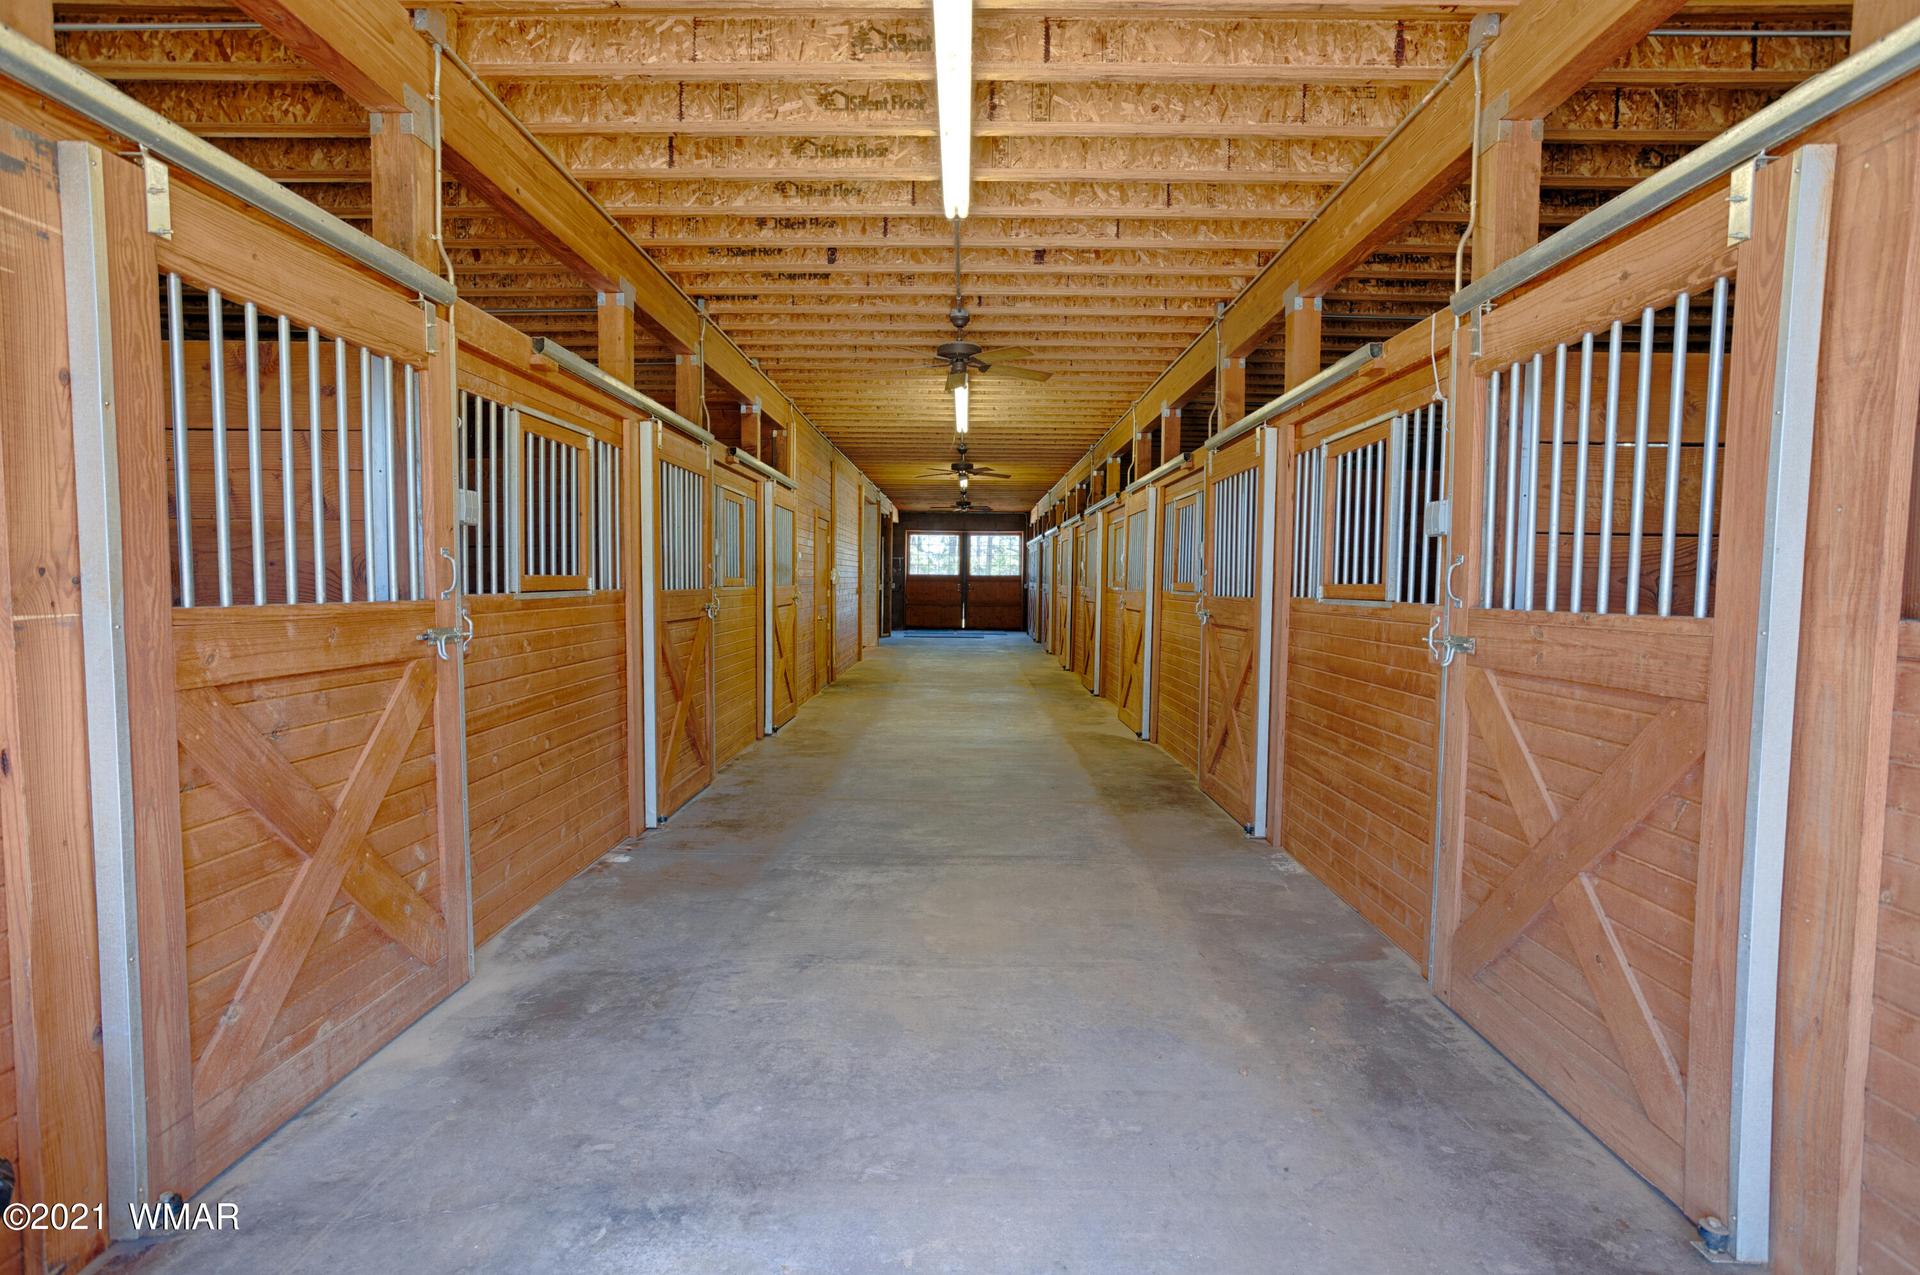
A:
[56,0,1847,511]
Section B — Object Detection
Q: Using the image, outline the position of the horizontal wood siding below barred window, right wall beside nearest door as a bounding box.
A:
[1281,601,1438,966]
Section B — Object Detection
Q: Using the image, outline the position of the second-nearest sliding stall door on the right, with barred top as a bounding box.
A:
[1198,430,1273,830]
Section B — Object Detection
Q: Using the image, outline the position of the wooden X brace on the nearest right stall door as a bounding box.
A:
[1455,666,1707,1139]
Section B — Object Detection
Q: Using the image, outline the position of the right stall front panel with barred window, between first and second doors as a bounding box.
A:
[1271,325,1444,968]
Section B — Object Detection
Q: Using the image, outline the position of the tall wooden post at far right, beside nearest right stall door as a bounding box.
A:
[1772,94,1920,1275]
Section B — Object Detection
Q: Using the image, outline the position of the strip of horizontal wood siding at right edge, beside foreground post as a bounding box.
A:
[1860,620,1920,1275]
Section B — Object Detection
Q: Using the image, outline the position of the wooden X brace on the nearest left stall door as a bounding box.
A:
[179,661,445,1102]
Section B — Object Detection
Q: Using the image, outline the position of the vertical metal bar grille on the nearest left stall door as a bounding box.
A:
[157,273,426,607]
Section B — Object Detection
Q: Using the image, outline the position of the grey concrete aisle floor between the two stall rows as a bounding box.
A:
[111,636,1699,1275]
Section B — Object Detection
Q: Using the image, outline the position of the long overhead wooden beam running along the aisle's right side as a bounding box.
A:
[1056,0,1682,518]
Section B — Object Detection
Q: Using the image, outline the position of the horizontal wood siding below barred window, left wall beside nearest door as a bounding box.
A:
[467,589,628,943]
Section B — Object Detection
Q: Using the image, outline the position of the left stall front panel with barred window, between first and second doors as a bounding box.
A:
[455,303,629,943]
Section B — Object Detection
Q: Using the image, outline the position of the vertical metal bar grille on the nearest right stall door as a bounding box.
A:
[1478,278,1734,618]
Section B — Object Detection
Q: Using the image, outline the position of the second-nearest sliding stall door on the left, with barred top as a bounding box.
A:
[653,424,720,816]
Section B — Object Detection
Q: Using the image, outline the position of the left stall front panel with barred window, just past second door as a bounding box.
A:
[712,465,760,766]
